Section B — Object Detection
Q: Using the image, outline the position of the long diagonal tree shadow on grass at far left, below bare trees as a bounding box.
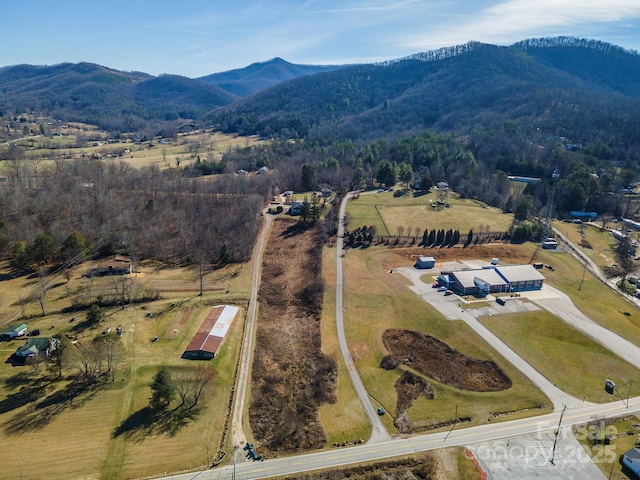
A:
[4,381,104,435]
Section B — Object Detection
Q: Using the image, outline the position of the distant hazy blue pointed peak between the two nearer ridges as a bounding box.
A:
[197,57,344,97]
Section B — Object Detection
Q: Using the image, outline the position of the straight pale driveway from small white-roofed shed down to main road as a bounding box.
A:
[396,267,586,410]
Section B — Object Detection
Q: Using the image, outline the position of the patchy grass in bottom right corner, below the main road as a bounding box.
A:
[574,415,638,480]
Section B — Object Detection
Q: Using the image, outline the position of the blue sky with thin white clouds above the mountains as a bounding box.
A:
[0,0,640,77]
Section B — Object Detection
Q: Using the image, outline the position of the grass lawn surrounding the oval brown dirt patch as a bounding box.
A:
[344,248,551,432]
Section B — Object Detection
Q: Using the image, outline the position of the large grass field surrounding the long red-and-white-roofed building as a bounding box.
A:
[0,264,251,479]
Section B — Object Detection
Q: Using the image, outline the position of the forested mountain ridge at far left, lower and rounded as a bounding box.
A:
[0,63,236,132]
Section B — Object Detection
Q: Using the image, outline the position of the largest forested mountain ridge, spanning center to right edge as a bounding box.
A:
[212,38,640,142]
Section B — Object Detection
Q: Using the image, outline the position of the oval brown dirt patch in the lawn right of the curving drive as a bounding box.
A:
[381,329,511,392]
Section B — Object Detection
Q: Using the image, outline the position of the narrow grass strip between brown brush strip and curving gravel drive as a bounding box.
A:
[319,248,371,445]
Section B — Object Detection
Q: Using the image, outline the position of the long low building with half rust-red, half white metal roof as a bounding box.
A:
[182,305,240,360]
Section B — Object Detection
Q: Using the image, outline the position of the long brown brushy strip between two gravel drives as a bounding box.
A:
[249,220,337,452]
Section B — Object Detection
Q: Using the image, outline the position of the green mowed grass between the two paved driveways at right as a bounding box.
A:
[480,311,640,403]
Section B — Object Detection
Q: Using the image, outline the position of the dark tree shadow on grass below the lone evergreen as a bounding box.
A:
[111,406,201,442]
